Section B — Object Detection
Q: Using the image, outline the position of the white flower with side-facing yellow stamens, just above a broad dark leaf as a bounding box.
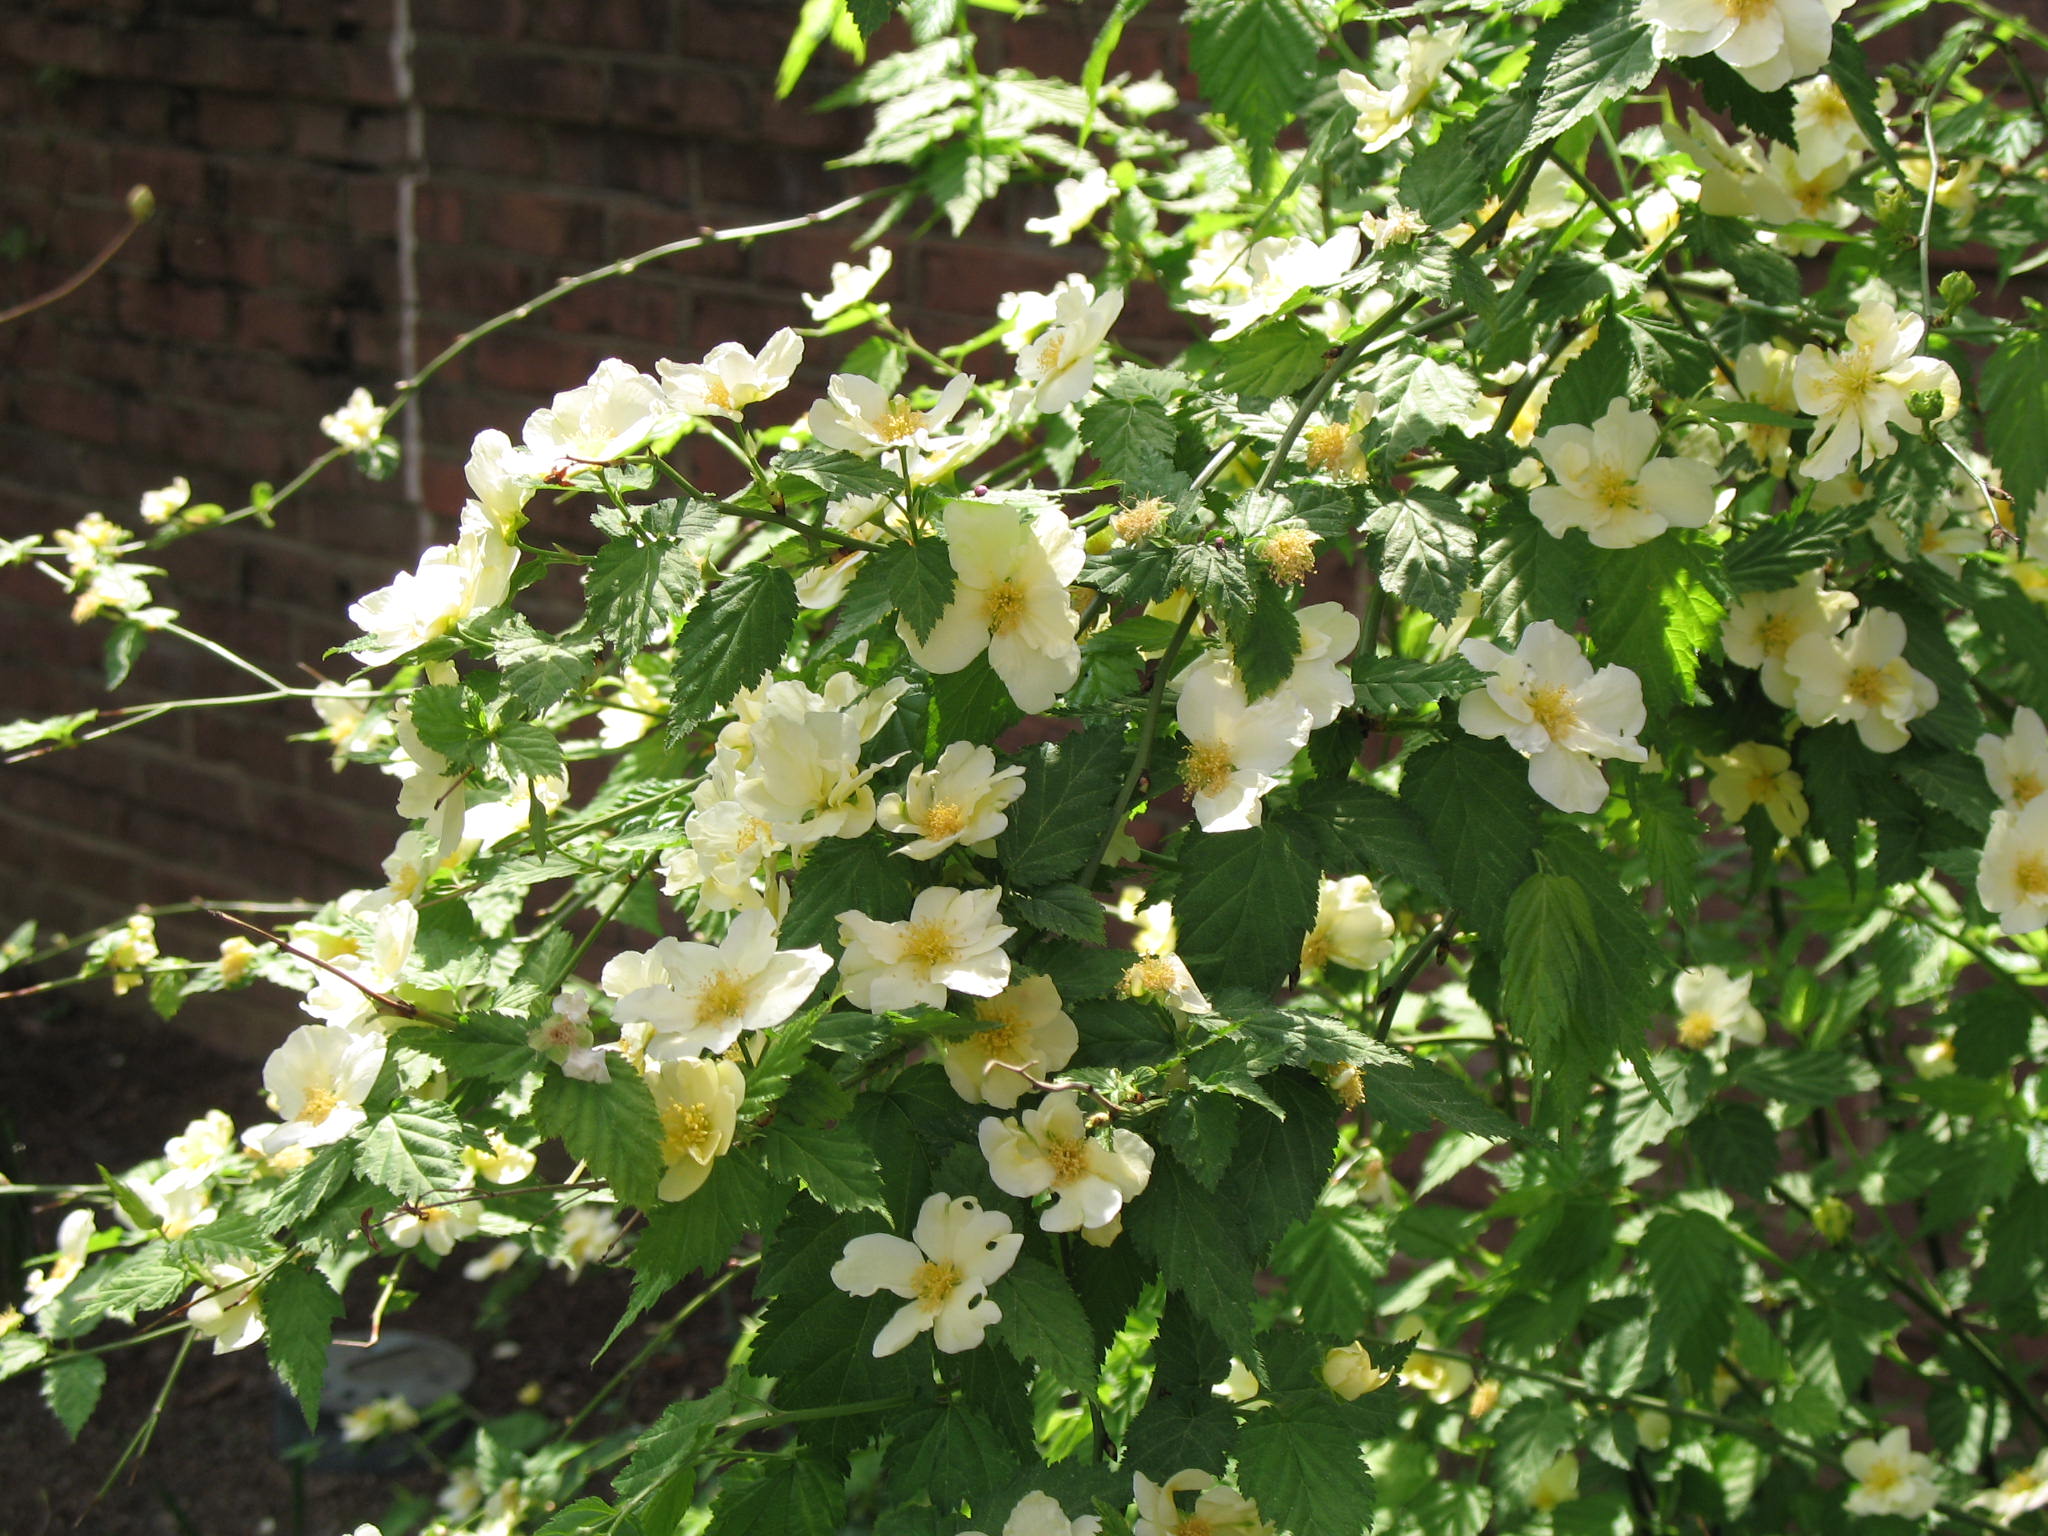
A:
[1174,651,1313,831]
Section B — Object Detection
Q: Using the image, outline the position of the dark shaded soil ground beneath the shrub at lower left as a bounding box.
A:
[0,993,735,1536]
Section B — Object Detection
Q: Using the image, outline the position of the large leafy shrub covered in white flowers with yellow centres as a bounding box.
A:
[0,0,2048,1536]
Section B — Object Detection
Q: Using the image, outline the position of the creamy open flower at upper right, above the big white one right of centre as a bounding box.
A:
[1530,395,1714,549]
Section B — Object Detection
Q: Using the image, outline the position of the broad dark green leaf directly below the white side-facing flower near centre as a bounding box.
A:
[1174,817,1319,991]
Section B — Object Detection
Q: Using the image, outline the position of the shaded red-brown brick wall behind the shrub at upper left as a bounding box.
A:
[0,0,1180,1051]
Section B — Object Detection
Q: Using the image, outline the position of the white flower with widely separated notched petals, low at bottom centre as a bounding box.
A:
[831,1194,1024,1360]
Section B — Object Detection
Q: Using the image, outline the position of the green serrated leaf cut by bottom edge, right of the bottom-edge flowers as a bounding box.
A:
[1237,1389,1376,1536]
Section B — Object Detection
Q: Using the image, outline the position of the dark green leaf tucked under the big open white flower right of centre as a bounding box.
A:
[1401,733,1542,934]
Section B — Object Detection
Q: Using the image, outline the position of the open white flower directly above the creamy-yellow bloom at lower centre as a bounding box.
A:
[840,885,1016,1014]
